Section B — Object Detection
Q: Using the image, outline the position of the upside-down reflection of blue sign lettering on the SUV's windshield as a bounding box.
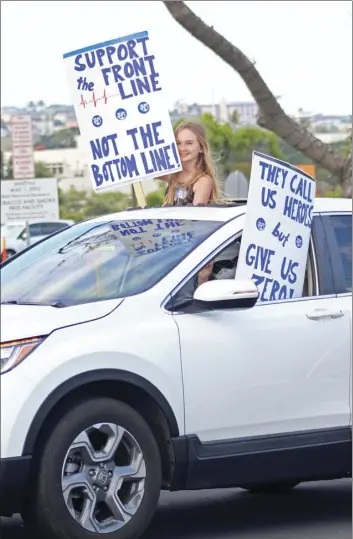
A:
[110,219,196,257]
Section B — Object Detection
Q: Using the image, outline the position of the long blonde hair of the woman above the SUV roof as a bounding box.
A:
[164,121,220,204]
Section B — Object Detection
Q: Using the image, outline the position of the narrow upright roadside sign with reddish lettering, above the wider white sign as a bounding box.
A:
[11,114,35,180]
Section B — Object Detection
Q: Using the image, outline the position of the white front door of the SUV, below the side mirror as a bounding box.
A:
[168,213,350,442]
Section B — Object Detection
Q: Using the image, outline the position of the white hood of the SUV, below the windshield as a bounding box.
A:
[0,299,124,342]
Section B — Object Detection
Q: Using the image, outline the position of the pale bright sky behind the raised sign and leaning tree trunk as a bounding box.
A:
[1,0,352,114]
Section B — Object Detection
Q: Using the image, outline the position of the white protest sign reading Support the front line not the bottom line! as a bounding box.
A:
[64,31,182,192]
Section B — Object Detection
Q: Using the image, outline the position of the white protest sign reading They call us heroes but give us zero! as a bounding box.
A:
[235,152,315,301]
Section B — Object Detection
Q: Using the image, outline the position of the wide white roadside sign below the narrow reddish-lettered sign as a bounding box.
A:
[1,178,59,223]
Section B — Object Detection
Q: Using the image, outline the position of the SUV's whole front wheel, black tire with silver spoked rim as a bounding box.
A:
[27,398,162,539]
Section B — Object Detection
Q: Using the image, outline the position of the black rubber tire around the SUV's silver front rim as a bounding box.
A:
[25,398,162,539]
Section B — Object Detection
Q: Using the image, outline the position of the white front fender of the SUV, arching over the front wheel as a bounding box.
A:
[1,288,184,458]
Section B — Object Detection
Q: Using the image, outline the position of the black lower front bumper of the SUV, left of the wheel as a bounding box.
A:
[0,457,32,517]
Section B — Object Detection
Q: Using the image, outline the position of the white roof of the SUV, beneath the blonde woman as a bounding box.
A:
[90,198,352,223]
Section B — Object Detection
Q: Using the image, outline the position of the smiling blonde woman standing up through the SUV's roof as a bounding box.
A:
[159,122,220,206]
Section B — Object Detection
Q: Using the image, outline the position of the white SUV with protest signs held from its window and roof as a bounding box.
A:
[0,199,352,539]
